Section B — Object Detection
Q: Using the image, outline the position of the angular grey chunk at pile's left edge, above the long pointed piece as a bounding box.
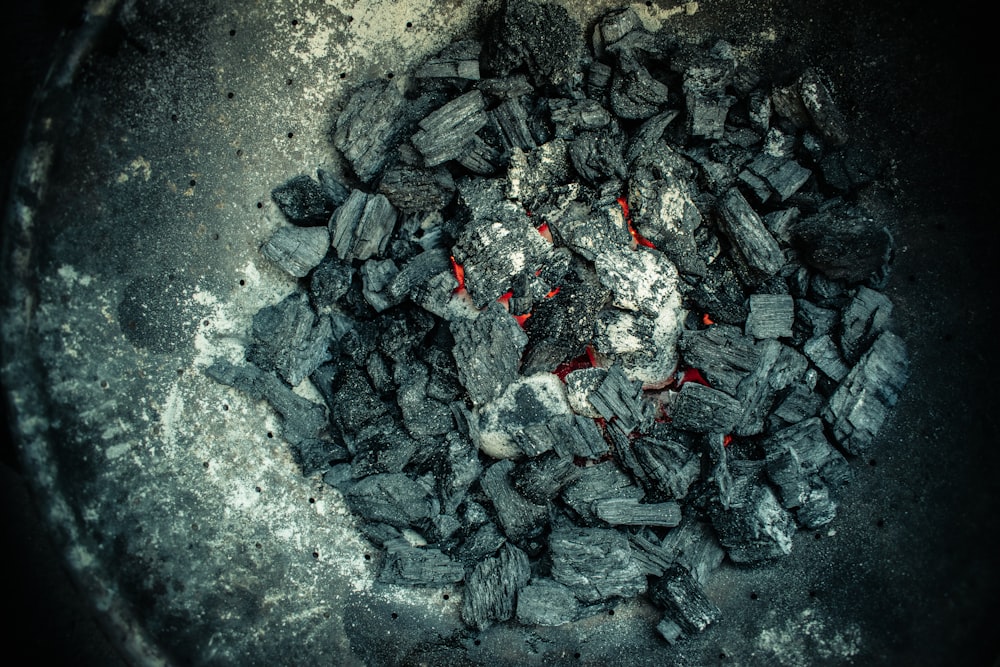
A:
[246,292,333,387]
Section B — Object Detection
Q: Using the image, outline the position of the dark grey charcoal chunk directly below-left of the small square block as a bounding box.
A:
[680,324,760,395]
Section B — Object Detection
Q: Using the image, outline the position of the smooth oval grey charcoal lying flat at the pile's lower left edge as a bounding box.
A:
[344,473,439,528]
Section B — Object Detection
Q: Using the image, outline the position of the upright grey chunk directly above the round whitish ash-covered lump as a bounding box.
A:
[451,301,528,405]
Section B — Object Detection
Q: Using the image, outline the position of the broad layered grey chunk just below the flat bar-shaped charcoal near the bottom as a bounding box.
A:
[549,527,646,603]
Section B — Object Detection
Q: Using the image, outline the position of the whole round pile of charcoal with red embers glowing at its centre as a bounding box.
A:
[207,0,908,642]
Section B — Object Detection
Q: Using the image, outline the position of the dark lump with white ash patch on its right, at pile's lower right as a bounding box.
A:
[712,461,795,563]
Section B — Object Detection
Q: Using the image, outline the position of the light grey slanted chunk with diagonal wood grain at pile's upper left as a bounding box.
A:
[410,89,486,167]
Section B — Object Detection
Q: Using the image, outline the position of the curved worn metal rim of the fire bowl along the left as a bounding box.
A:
[0,0,170,667]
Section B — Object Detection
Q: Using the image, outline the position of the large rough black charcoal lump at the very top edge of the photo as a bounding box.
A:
[481,0,583,86]
